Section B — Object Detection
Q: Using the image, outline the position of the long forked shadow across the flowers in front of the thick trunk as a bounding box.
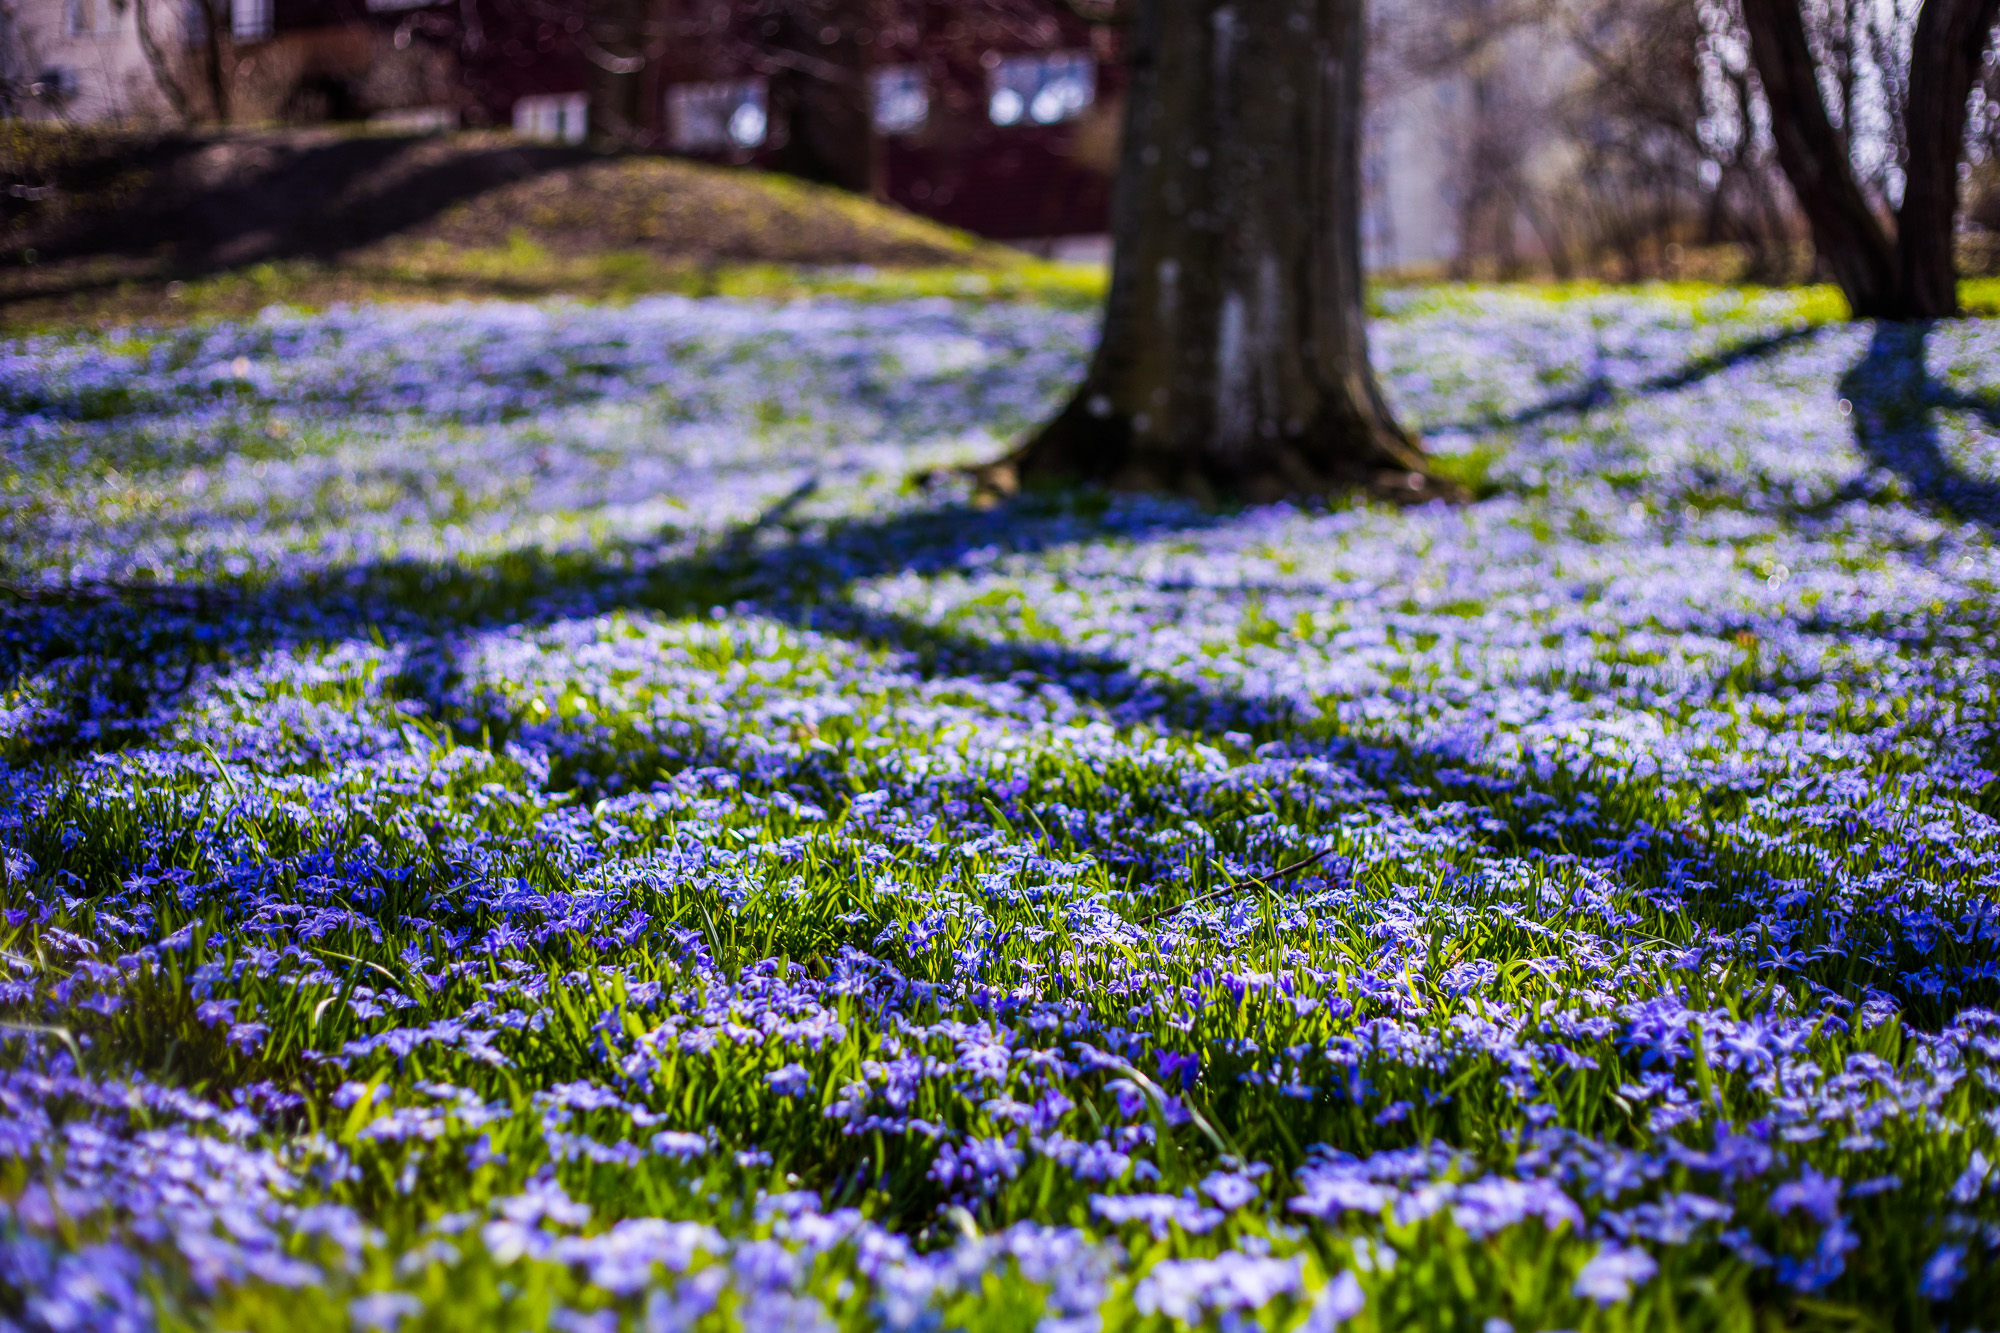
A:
[0,474,1982,1021]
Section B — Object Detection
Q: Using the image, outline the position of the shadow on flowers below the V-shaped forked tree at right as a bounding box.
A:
[1840,320,2000,526]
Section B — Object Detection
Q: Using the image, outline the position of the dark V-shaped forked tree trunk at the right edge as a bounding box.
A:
[1742,0,2000,320]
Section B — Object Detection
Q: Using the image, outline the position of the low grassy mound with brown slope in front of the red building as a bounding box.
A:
[0,130,1018,326]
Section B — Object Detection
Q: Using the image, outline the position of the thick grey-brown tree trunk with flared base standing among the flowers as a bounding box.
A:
[1008,0,1452,500]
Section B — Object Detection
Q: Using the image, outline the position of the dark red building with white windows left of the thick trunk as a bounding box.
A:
[464,0,1124,240]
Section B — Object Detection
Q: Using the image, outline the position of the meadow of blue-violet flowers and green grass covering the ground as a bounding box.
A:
[0,290,2000,1333]
